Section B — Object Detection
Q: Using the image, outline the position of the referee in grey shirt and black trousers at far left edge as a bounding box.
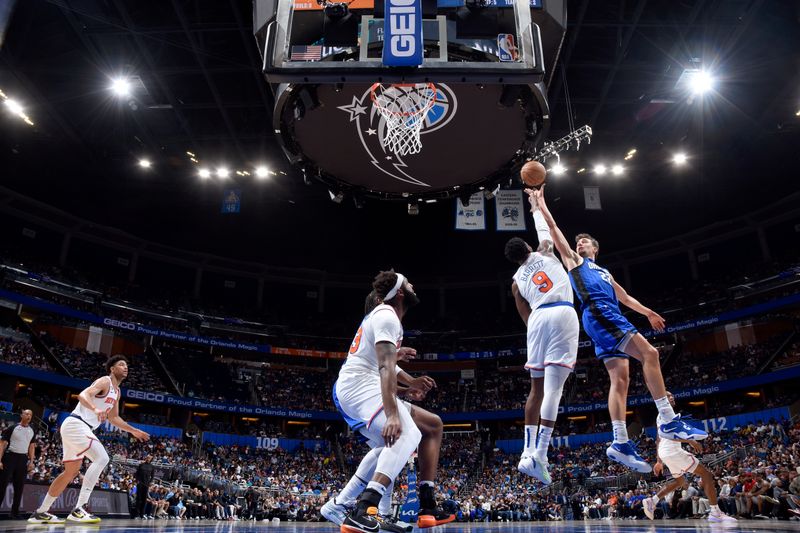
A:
[0,409,36,519]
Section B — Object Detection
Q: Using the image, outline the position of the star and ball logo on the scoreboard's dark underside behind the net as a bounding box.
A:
[338,83,458,187]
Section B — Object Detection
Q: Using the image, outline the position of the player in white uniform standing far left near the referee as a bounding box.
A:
[28,355,150,524]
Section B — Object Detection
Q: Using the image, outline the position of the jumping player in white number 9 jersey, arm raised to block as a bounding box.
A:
[505,192,580,485]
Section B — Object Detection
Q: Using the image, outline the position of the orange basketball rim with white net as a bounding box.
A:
[370,83,436,156]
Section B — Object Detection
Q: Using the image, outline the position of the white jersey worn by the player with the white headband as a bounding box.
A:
[339,304,403,380]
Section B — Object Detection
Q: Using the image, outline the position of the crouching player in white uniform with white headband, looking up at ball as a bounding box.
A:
[335,271,422,533]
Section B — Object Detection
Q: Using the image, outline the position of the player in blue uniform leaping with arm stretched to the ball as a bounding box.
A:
[527,187,708,473]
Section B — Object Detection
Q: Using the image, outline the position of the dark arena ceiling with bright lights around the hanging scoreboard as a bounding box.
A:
[0,0,800,274]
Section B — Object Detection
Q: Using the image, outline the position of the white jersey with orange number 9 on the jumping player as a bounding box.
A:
[514,252,572,311]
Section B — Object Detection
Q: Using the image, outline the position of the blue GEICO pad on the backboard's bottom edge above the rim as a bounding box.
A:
[383,0,423,67]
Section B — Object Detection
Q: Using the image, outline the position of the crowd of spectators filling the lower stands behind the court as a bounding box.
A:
[3,414,800,521]
